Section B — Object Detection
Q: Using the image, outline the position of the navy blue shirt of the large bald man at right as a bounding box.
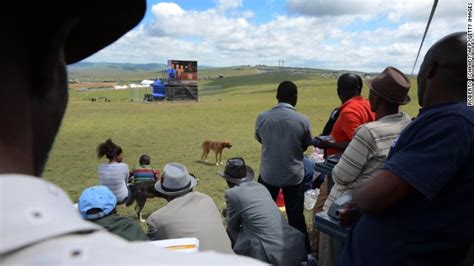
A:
[338,102,474,266]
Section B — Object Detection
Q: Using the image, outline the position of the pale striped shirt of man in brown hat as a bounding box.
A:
[323,113,411,210]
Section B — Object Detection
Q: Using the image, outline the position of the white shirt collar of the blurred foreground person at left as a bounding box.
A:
[0,174,104,255]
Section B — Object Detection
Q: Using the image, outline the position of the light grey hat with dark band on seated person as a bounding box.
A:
[155,163,197,196]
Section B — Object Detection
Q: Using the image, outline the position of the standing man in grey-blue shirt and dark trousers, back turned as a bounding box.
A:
[255,81,312,253]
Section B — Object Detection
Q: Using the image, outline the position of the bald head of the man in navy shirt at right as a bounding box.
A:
[418,32,467,107]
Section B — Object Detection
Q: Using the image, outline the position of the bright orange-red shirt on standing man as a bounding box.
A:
[327,96,375,155]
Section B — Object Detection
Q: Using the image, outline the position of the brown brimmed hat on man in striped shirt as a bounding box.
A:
[366,67,411,105]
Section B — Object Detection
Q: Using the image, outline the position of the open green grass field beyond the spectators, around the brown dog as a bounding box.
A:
[44,70,418,226]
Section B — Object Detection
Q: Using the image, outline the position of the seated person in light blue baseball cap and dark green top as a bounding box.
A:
[78,186,148,241]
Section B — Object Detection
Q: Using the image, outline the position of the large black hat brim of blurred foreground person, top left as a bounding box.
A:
[21,0,146,64]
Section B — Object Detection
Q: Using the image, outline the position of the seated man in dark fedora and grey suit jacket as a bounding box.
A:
[219,157,306,265]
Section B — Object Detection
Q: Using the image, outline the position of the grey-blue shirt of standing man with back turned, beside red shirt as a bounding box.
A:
[255,103,312,187]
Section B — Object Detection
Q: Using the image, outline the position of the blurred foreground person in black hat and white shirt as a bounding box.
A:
[0,0,260,265]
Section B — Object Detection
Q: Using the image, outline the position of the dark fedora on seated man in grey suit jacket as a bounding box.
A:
[217,157,255,184]
